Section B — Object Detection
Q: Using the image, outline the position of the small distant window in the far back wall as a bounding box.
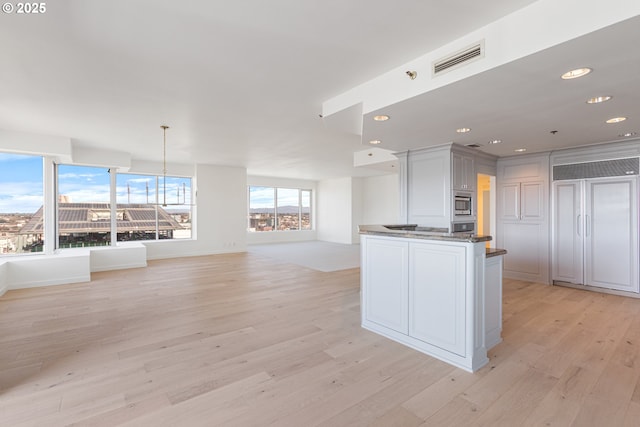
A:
[248,186,311,232]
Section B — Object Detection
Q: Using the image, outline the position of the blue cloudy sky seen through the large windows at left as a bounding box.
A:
[0,153,191,213]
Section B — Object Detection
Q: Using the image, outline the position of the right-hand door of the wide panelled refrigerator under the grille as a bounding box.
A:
[585,178,638,292]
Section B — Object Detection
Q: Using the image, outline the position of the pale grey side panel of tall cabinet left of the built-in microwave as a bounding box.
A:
[362,174,400,224]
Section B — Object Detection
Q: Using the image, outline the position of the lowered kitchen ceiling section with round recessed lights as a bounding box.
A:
[362,16,640,157]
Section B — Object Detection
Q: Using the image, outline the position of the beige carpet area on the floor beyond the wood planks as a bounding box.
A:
[248,241,360,272]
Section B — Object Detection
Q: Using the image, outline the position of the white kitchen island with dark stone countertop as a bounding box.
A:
[360,225,506,372]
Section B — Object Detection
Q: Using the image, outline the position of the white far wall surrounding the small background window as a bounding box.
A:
[244,175,318,245]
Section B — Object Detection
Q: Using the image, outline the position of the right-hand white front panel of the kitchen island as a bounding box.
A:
[409,243,466,356]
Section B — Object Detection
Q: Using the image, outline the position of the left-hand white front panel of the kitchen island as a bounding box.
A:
[362,237,409,334]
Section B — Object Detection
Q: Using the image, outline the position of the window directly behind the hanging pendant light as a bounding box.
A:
[116,174,191,241]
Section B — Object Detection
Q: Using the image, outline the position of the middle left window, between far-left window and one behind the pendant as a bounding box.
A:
[57,165,111,248]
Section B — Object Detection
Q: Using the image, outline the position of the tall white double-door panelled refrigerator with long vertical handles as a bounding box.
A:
[552,172,640,292]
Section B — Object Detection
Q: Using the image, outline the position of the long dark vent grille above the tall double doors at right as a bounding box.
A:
[553,157,640,181]
